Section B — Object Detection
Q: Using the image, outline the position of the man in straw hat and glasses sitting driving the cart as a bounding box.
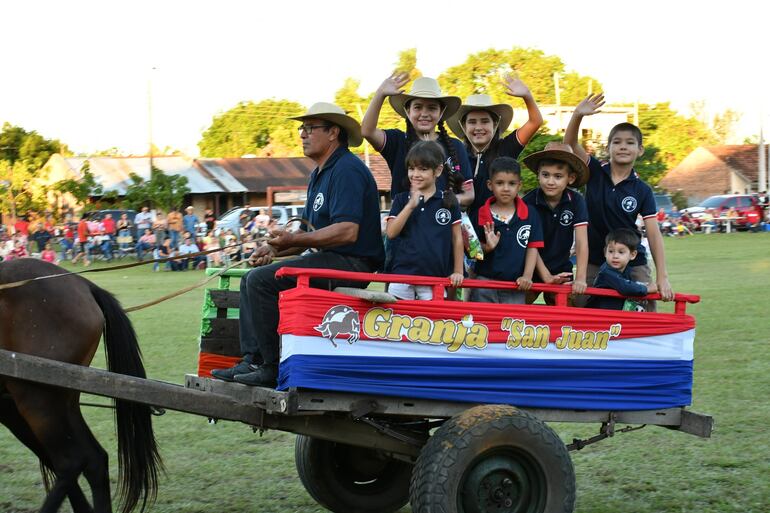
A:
[211,102,385,387]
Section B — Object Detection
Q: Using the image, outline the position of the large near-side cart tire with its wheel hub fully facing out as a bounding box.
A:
[410,405,575,513]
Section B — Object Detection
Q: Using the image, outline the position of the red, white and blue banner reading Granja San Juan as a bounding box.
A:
[278,288,695,410]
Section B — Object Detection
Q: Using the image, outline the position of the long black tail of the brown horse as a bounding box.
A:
[90,283,163,513]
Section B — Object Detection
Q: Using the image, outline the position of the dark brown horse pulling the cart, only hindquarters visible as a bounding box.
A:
[0,258,162,513]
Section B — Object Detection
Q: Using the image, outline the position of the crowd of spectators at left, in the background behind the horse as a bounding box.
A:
[0,206,282,271]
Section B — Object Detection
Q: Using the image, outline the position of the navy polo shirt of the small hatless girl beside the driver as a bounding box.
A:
[388,190,460,276]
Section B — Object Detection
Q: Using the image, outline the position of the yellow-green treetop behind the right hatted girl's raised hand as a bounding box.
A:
[439,47,601,107]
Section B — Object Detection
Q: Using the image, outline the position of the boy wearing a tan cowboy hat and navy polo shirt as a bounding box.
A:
[524,142,589,305]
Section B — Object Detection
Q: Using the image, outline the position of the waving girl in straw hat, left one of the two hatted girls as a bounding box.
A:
[361,73,473,205]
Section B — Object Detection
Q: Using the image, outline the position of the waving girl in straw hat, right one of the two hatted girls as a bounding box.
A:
[447,75,543,223]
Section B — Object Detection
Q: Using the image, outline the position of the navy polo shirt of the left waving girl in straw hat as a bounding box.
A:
[380,128,473,198]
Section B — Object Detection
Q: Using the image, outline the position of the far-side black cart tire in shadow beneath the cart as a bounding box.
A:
[294,435,413,513]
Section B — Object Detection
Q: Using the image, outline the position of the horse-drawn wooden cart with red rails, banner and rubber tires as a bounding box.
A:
[0,269,712,513]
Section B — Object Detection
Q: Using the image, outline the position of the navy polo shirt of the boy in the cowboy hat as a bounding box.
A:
[524,187,588,274]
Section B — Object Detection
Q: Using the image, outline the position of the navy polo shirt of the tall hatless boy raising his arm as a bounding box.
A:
[586,157,657,266]
